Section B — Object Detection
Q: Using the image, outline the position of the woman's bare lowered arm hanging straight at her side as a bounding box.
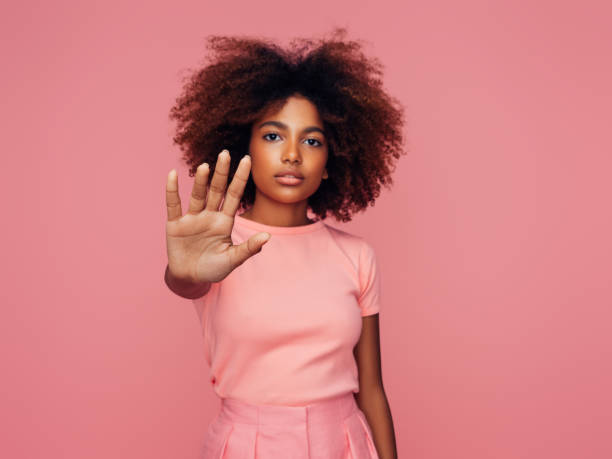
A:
[353,314,397,459]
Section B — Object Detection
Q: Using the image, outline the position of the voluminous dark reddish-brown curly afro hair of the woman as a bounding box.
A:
[170,28,405,222]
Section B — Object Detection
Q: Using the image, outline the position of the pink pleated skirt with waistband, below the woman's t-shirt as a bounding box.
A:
[200,392,378,459]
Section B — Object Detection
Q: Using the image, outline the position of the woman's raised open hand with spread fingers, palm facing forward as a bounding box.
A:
[166,150,270,283]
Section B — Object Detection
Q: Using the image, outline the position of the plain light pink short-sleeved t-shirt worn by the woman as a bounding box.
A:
[192,215,380,406]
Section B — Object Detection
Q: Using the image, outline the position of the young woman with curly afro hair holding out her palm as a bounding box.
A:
[165,29,403,459]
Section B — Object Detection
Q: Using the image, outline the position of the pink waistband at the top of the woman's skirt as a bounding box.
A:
[219,392,358,425]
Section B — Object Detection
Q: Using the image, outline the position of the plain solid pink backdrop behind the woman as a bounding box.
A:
[0,0,612,459]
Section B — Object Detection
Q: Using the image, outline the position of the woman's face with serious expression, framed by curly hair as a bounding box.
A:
[249,94,328,204]
